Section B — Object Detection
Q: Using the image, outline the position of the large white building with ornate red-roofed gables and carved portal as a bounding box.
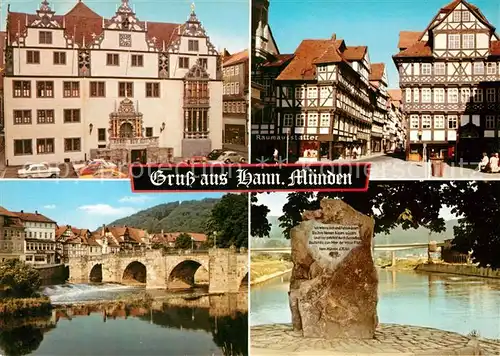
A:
[4,0,223,165]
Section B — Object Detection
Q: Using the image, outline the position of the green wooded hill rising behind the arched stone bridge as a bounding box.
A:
[108,198,220,233]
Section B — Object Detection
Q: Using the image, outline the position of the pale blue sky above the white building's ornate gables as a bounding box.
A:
[0,0,250,53]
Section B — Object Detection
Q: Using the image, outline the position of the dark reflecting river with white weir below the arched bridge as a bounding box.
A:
[0,284,248,356]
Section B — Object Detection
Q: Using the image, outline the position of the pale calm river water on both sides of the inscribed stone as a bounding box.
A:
[250,269,500,339]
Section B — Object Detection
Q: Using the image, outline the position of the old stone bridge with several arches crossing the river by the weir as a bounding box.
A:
[67,248,248,294]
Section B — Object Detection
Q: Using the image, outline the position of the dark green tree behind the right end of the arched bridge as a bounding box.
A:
[206,194,248,248]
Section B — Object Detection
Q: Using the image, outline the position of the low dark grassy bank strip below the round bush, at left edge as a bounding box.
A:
[0,297,53,318]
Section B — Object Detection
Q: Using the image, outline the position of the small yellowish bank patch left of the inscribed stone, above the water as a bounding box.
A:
[250,255,293,286]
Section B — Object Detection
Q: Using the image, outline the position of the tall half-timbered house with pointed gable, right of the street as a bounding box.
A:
[393,0,500,162]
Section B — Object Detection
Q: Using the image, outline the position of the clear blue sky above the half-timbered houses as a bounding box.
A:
[269,0,500,88]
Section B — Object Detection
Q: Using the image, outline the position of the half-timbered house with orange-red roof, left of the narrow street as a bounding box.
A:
[266,35,372,161]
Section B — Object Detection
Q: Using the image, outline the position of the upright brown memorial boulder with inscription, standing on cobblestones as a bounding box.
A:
[289,199,378,339]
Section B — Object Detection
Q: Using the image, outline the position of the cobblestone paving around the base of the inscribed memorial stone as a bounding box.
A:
[250,324,500,356]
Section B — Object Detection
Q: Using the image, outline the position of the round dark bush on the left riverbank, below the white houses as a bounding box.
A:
[0,259,42,298]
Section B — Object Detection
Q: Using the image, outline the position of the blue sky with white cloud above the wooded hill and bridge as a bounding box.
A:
[0,179,223,230]
